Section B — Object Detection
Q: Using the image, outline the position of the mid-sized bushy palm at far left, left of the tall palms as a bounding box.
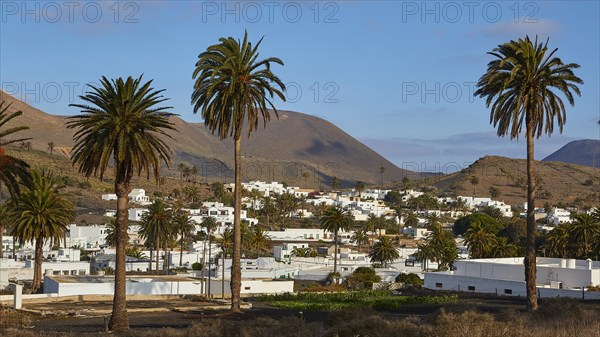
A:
[12,171,75,292]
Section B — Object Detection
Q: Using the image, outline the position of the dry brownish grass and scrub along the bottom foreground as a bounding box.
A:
[0,299,600,337]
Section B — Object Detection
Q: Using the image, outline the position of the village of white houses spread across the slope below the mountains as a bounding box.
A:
[0,181,600,298]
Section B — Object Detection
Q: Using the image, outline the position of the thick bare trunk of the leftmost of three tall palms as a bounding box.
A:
[109,181,131,331]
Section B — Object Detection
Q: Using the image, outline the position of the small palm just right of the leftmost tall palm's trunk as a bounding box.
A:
[139,199,177,271]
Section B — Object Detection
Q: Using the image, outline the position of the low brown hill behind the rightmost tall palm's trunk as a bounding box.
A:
[422,156,600,206]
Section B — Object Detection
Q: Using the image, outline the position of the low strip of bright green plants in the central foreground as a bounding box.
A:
[257,290,458,311]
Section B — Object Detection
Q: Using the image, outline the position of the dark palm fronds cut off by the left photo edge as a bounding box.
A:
[0,101,31,199]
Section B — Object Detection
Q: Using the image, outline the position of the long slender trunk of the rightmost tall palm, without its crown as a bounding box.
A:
[524,121,538,310]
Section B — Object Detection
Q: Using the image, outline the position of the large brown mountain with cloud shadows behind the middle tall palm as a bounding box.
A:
[0,91,417,187]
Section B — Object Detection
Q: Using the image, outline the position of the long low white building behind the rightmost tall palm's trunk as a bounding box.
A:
[425,257,600,299]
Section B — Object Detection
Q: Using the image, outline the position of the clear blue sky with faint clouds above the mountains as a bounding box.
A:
[0,0,600,171]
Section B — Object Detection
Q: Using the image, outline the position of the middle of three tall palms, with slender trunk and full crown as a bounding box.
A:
[192,32,285,312]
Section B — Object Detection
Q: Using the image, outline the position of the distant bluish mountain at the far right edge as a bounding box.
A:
[542,139,600,167]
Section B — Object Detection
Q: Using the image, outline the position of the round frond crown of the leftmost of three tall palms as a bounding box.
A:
[67,76,175,180]
